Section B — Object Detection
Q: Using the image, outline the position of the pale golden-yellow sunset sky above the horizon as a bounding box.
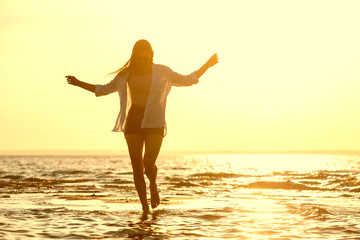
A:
[0,0,360,151]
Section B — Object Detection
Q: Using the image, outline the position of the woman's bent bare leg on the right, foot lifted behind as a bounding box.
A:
[144,134,163,208]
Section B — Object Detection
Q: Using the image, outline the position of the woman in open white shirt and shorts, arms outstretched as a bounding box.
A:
[66,40,218,214]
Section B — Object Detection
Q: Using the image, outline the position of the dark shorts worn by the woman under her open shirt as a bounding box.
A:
[124,105,164,137]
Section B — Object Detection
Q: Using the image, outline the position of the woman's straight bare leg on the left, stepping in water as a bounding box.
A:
[125,134,149,214]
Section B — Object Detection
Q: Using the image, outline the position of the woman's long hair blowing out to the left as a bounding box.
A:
[108,39,154,75]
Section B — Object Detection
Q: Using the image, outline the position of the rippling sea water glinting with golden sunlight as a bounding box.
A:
[0,153,360,240]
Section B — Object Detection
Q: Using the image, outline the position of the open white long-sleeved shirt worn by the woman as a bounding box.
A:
[95,64,199,132]
